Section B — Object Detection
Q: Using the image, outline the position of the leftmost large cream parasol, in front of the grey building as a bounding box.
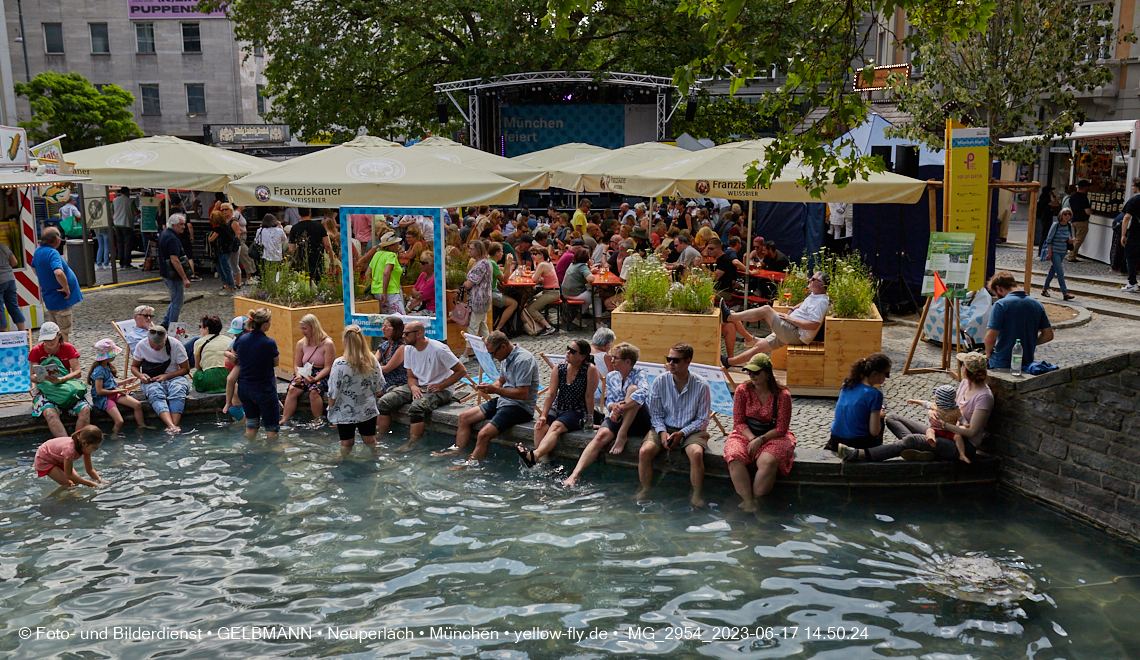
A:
[66,136,272,192]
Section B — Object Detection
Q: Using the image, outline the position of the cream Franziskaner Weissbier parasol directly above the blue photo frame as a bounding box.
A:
[226,136,519,209]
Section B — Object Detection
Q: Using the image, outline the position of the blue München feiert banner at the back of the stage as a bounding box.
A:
[496,104,626,158]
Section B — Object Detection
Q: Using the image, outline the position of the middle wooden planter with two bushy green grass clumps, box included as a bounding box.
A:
[610,255,720,365]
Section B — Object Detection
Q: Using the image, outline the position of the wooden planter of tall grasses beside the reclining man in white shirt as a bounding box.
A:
[772,250,882,389]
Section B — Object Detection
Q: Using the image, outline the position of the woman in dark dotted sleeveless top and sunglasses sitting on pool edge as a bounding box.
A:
[518,340,601,467]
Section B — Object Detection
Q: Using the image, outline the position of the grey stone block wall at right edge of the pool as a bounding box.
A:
[987,352,1140,541]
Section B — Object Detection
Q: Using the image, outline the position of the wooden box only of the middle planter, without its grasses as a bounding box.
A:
[610,308,722,366]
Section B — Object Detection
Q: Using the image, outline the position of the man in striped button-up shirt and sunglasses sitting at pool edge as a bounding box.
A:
[637,343,711,506]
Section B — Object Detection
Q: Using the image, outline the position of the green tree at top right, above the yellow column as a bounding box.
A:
[891,0,1135,163]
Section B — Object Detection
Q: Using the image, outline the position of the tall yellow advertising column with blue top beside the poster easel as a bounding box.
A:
[943,120,990,291]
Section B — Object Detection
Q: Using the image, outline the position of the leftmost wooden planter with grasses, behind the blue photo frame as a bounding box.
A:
[234,261,380,380]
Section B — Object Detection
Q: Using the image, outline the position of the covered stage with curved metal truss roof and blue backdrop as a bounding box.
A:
[435,71,700,157]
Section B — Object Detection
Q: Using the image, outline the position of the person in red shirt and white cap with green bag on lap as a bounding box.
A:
[27,320,91,438]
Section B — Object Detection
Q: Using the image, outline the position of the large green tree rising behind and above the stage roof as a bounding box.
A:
[200,0,705,141]
